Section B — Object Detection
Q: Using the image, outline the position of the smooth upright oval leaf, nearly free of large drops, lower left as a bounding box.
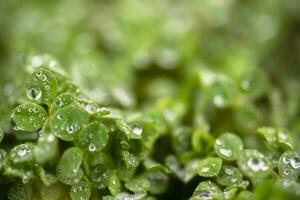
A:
[56,147,83,185]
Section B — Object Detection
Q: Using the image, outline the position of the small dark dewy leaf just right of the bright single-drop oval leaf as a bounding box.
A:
[217,165,243,186]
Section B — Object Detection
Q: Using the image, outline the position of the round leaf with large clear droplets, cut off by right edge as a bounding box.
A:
[278,151,300,180]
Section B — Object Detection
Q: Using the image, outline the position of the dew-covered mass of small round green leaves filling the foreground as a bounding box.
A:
[0,64,300,200]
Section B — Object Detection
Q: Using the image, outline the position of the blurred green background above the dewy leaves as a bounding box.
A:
[0,0,300,138]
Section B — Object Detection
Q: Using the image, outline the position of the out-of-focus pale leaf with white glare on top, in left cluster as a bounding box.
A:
[34,134,58,163]
